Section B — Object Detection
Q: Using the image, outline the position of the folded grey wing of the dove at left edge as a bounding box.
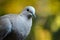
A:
[0,17,12,40]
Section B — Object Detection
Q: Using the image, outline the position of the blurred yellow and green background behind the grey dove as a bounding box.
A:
[0,0,60,40]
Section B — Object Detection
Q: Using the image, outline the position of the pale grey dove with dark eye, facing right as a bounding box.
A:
[0,6,36,40]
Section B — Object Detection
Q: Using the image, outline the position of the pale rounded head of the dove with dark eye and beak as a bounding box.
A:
[22,6,36,19]
